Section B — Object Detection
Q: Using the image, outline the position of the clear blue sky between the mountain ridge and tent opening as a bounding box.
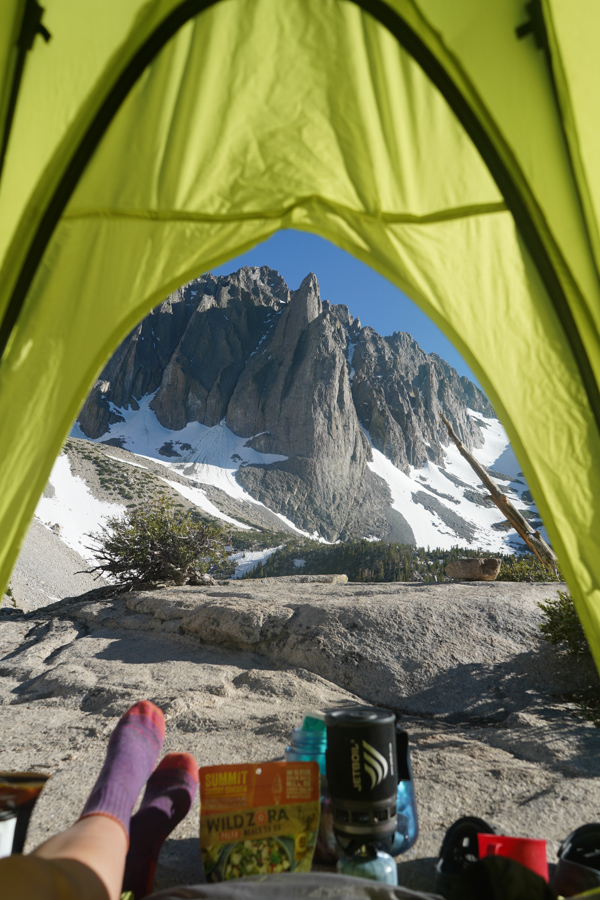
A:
[213,231,476,381]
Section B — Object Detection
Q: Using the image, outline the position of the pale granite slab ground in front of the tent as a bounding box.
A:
[0,579,600,890]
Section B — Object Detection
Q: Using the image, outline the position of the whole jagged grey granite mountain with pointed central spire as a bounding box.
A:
[78,266,493,543]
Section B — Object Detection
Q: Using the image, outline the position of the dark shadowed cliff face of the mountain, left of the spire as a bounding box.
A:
[79,267,289,438]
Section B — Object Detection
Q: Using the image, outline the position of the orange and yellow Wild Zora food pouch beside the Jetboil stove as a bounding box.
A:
[200,762,320,881]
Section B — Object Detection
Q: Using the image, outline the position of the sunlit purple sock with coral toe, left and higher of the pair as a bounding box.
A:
[79,700,165,837]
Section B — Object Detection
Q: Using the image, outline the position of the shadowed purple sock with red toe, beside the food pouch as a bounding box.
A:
[123,753,198,900]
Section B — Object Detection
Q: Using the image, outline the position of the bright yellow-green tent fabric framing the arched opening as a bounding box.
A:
[0,0,600,663]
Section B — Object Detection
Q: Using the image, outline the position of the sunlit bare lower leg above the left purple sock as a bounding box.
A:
[32,815,129,900]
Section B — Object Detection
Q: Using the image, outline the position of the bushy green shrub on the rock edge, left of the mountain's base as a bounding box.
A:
[90,497,229,588]
